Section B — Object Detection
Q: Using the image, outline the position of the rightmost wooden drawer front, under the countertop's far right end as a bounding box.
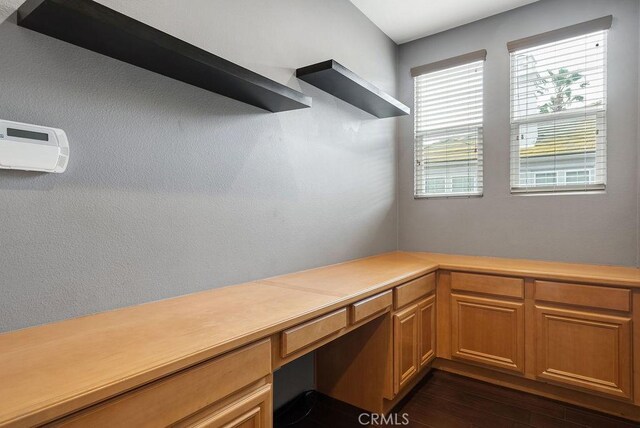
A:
[535,281,631,312]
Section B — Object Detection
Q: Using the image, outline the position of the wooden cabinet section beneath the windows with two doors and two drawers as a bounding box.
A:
[438,272,633,401]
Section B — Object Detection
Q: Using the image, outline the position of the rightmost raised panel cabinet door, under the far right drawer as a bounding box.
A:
[536,306,632,398]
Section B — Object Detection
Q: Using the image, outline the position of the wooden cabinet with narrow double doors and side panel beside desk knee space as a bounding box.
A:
[316,275,436,413]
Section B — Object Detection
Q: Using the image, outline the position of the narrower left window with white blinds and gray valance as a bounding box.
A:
[411,51,486,197]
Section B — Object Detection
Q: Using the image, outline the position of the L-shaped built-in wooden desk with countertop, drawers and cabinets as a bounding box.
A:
[0,252,640,426]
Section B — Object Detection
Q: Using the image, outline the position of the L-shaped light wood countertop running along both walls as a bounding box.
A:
[0,252,640,426]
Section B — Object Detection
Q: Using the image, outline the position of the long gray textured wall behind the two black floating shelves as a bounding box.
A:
[0,0,397,331]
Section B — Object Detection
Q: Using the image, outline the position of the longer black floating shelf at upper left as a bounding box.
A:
[18,0,311,112]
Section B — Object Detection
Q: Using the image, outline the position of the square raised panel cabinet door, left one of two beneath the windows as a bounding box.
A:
[451,294,524,373]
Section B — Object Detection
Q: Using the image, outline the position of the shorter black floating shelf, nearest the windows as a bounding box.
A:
[296,59,411,118]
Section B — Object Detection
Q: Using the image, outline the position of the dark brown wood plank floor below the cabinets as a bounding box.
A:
[275,370,640,428]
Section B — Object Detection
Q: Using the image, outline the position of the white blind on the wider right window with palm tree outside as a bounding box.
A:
[510,21,611,193]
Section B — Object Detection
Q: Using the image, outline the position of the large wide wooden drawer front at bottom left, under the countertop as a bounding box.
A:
[50,340,271,427]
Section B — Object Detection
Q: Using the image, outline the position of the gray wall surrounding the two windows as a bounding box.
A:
[398,0,640,265]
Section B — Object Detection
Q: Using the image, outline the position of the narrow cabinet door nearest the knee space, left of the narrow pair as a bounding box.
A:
[393,305,418,394]
